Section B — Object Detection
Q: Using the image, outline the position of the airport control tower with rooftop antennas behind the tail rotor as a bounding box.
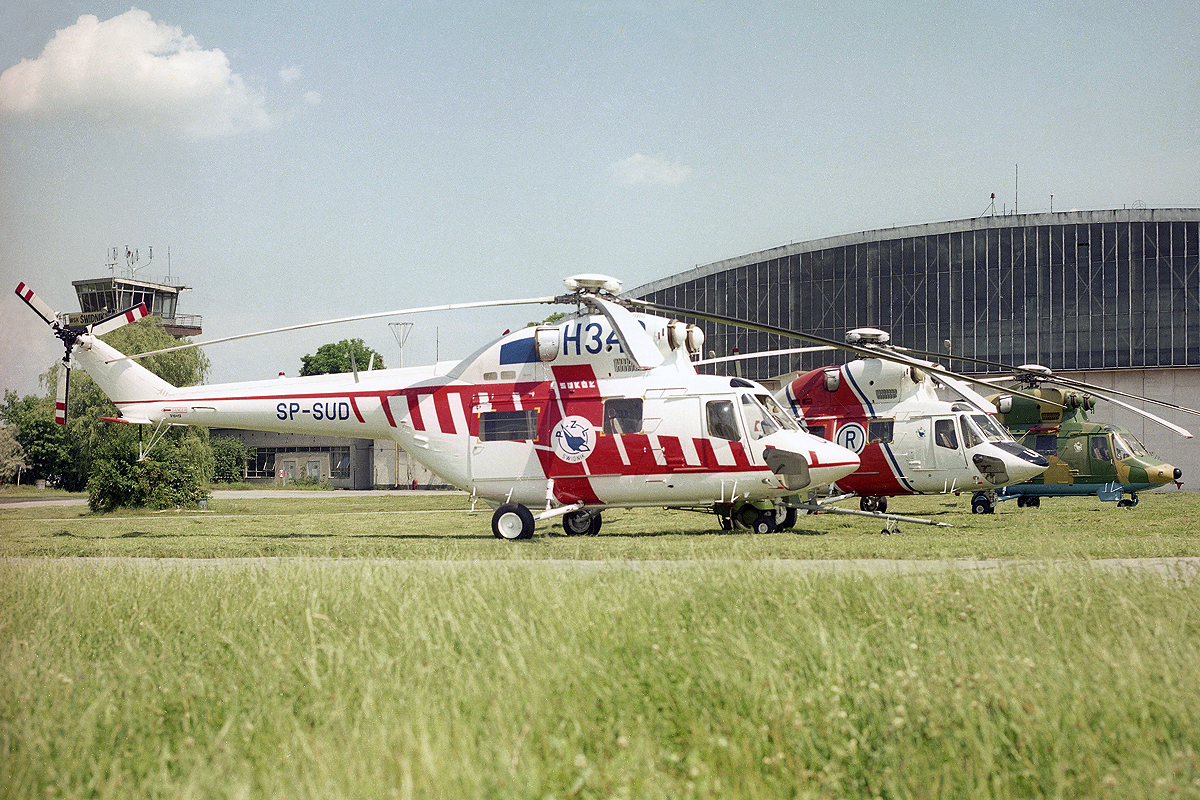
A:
[67,247,203,338]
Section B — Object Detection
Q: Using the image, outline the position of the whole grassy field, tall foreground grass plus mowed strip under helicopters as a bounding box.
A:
[0,493,1200,798]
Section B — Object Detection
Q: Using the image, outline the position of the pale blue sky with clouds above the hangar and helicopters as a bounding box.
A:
[0,0,1200,393]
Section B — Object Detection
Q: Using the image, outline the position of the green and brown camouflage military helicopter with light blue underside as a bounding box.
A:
[986,365,1200,507]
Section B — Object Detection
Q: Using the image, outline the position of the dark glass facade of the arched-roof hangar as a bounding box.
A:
[630,209,1200,379]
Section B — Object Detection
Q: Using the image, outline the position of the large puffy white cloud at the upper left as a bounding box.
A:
[0,8,271,139]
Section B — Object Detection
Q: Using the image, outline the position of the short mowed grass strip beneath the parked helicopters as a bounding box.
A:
[0,491,1200,561]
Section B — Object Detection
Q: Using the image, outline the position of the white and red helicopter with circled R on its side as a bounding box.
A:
[638,302,1050,513]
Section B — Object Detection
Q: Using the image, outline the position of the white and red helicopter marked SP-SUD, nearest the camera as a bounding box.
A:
[17,275,859,540]
